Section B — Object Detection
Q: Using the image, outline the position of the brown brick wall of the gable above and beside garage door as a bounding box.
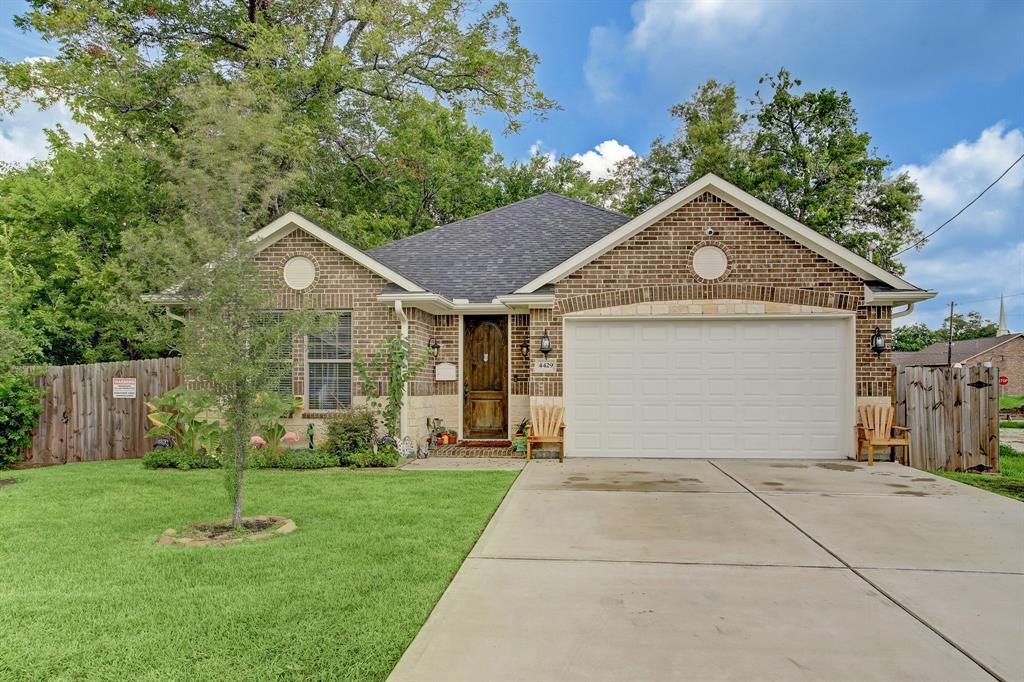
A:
[530,193,891,397]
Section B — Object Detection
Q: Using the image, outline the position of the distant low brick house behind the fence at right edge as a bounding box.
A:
[893,334,1024,395]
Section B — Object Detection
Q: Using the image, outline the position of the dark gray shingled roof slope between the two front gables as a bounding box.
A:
[369,193,630,296]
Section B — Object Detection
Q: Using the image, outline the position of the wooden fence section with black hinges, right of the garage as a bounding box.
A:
[894,367,999,472]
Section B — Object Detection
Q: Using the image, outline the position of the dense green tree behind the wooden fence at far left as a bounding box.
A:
[0,131,165,365]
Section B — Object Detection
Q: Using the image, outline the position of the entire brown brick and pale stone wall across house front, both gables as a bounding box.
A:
[256,193,901,440]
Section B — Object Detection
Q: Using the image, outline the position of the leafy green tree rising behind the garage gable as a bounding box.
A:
[616,70,922,273]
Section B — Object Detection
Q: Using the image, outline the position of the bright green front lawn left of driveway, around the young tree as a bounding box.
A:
[0,461,516,681]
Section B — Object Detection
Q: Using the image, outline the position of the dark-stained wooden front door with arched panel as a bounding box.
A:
[462,315,509,439]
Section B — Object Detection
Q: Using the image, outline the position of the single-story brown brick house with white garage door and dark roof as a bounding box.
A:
[155,175,935,458]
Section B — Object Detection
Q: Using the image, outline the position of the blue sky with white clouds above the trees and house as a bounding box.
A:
[0,0,1024,331]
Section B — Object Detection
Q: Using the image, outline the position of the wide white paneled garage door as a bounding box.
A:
[565,317,853,458]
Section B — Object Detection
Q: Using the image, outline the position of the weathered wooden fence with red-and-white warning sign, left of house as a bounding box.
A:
[25,357,181,465]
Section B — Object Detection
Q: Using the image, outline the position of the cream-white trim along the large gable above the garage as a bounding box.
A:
[515,173,918,294]
